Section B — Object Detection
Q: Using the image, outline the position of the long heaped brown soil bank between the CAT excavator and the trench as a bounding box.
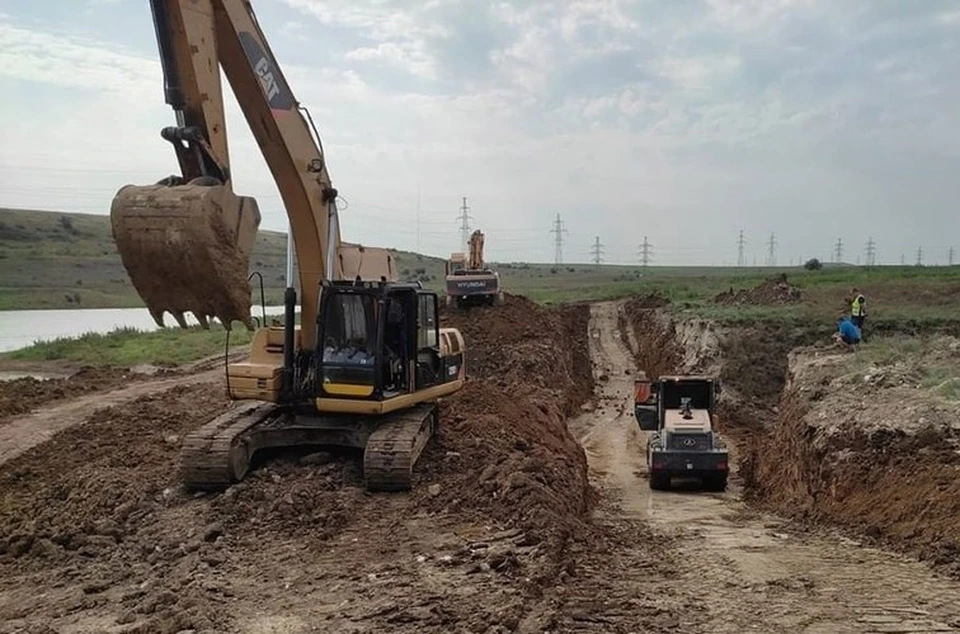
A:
[427,295,593,568]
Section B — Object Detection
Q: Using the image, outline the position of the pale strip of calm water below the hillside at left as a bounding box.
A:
[0,306,283,352]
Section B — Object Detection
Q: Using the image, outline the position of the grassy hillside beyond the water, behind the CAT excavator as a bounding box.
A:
[0,209,444,310]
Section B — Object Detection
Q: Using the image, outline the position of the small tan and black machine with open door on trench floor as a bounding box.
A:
[634,375,729,491]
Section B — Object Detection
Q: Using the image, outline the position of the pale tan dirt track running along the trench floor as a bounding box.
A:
[571,303,960,634]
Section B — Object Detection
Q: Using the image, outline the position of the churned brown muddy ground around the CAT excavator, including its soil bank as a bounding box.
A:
[0,297,684,632]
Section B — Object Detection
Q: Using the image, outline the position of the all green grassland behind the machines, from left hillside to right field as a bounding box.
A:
[0,210,960,364]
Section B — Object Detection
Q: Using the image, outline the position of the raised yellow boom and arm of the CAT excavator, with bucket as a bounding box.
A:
[111,0,396,350]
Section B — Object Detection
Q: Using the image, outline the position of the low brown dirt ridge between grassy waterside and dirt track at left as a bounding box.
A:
[0,366,161,424]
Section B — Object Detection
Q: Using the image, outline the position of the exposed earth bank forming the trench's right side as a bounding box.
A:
[619,298,960,576]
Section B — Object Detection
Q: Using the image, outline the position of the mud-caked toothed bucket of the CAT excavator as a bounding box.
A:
[110,177,260,330]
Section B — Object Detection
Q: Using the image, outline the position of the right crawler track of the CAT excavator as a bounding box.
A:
[363,404,438,491]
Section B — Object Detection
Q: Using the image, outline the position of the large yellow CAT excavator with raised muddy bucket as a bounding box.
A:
[110,0,465,490]
